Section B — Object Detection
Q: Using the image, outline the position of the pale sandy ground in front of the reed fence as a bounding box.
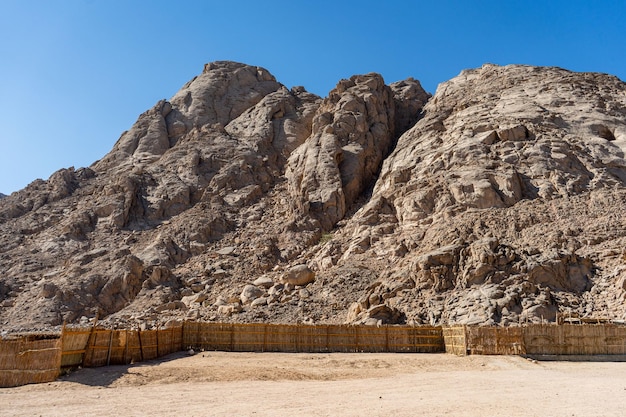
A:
[0,352,626,417]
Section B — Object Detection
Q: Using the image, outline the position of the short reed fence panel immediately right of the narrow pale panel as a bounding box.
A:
[466,327,526,355]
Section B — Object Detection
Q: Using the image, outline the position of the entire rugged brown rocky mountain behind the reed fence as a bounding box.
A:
[0,62,626,329]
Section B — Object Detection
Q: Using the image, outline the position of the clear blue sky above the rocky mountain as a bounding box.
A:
[0,0,626,194]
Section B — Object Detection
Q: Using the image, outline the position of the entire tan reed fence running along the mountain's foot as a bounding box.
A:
[0,322,626,387]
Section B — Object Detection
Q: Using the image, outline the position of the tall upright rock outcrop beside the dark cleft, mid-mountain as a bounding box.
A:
[286,74,428,230]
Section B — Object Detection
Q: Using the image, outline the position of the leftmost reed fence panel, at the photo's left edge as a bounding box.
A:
[0,335,61,388]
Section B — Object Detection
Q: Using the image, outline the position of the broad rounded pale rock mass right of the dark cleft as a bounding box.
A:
[326,65,626,324]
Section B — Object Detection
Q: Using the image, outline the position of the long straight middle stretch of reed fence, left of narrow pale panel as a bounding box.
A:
[183,322,444,353]
